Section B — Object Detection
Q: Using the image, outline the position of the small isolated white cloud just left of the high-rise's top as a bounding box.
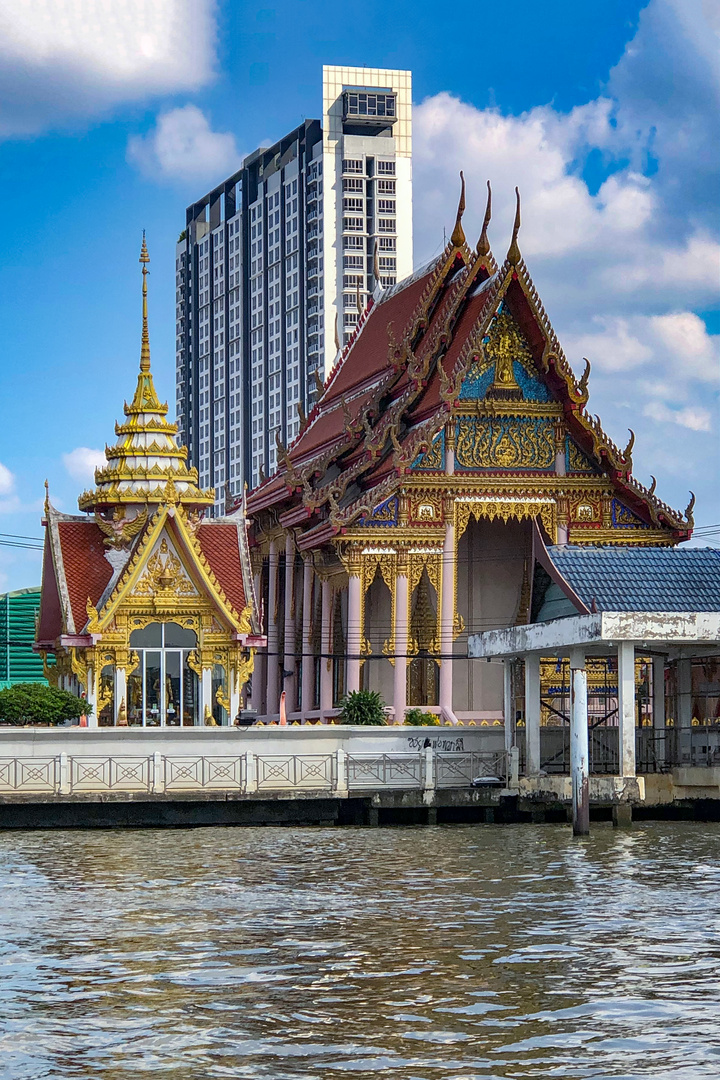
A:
[127,105,241,184]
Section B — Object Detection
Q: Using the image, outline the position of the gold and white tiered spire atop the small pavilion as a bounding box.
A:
[78,233,215,511]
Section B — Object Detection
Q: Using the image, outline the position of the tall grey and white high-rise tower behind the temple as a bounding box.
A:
[175,67,412,512]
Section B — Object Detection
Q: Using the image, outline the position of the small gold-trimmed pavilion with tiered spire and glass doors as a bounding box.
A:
[36,238,266,727]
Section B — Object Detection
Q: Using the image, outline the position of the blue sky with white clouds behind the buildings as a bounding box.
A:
[0,0,720,590]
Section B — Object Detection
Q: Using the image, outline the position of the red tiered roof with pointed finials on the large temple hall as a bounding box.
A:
[247,182,692,548]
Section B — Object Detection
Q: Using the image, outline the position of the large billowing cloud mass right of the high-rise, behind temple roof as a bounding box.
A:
[413,0,720,521]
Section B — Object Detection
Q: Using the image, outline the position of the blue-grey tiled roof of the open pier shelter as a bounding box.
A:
[547,544,720,611]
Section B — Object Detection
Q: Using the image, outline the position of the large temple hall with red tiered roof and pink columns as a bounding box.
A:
[246,183,693,724]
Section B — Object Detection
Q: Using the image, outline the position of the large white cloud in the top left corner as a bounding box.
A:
[0,0,215,135]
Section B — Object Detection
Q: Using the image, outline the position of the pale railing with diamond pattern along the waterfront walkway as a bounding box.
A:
[0,748,517,798]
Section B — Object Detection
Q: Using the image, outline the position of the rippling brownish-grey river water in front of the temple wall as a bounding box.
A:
[0,823,720,1080]
